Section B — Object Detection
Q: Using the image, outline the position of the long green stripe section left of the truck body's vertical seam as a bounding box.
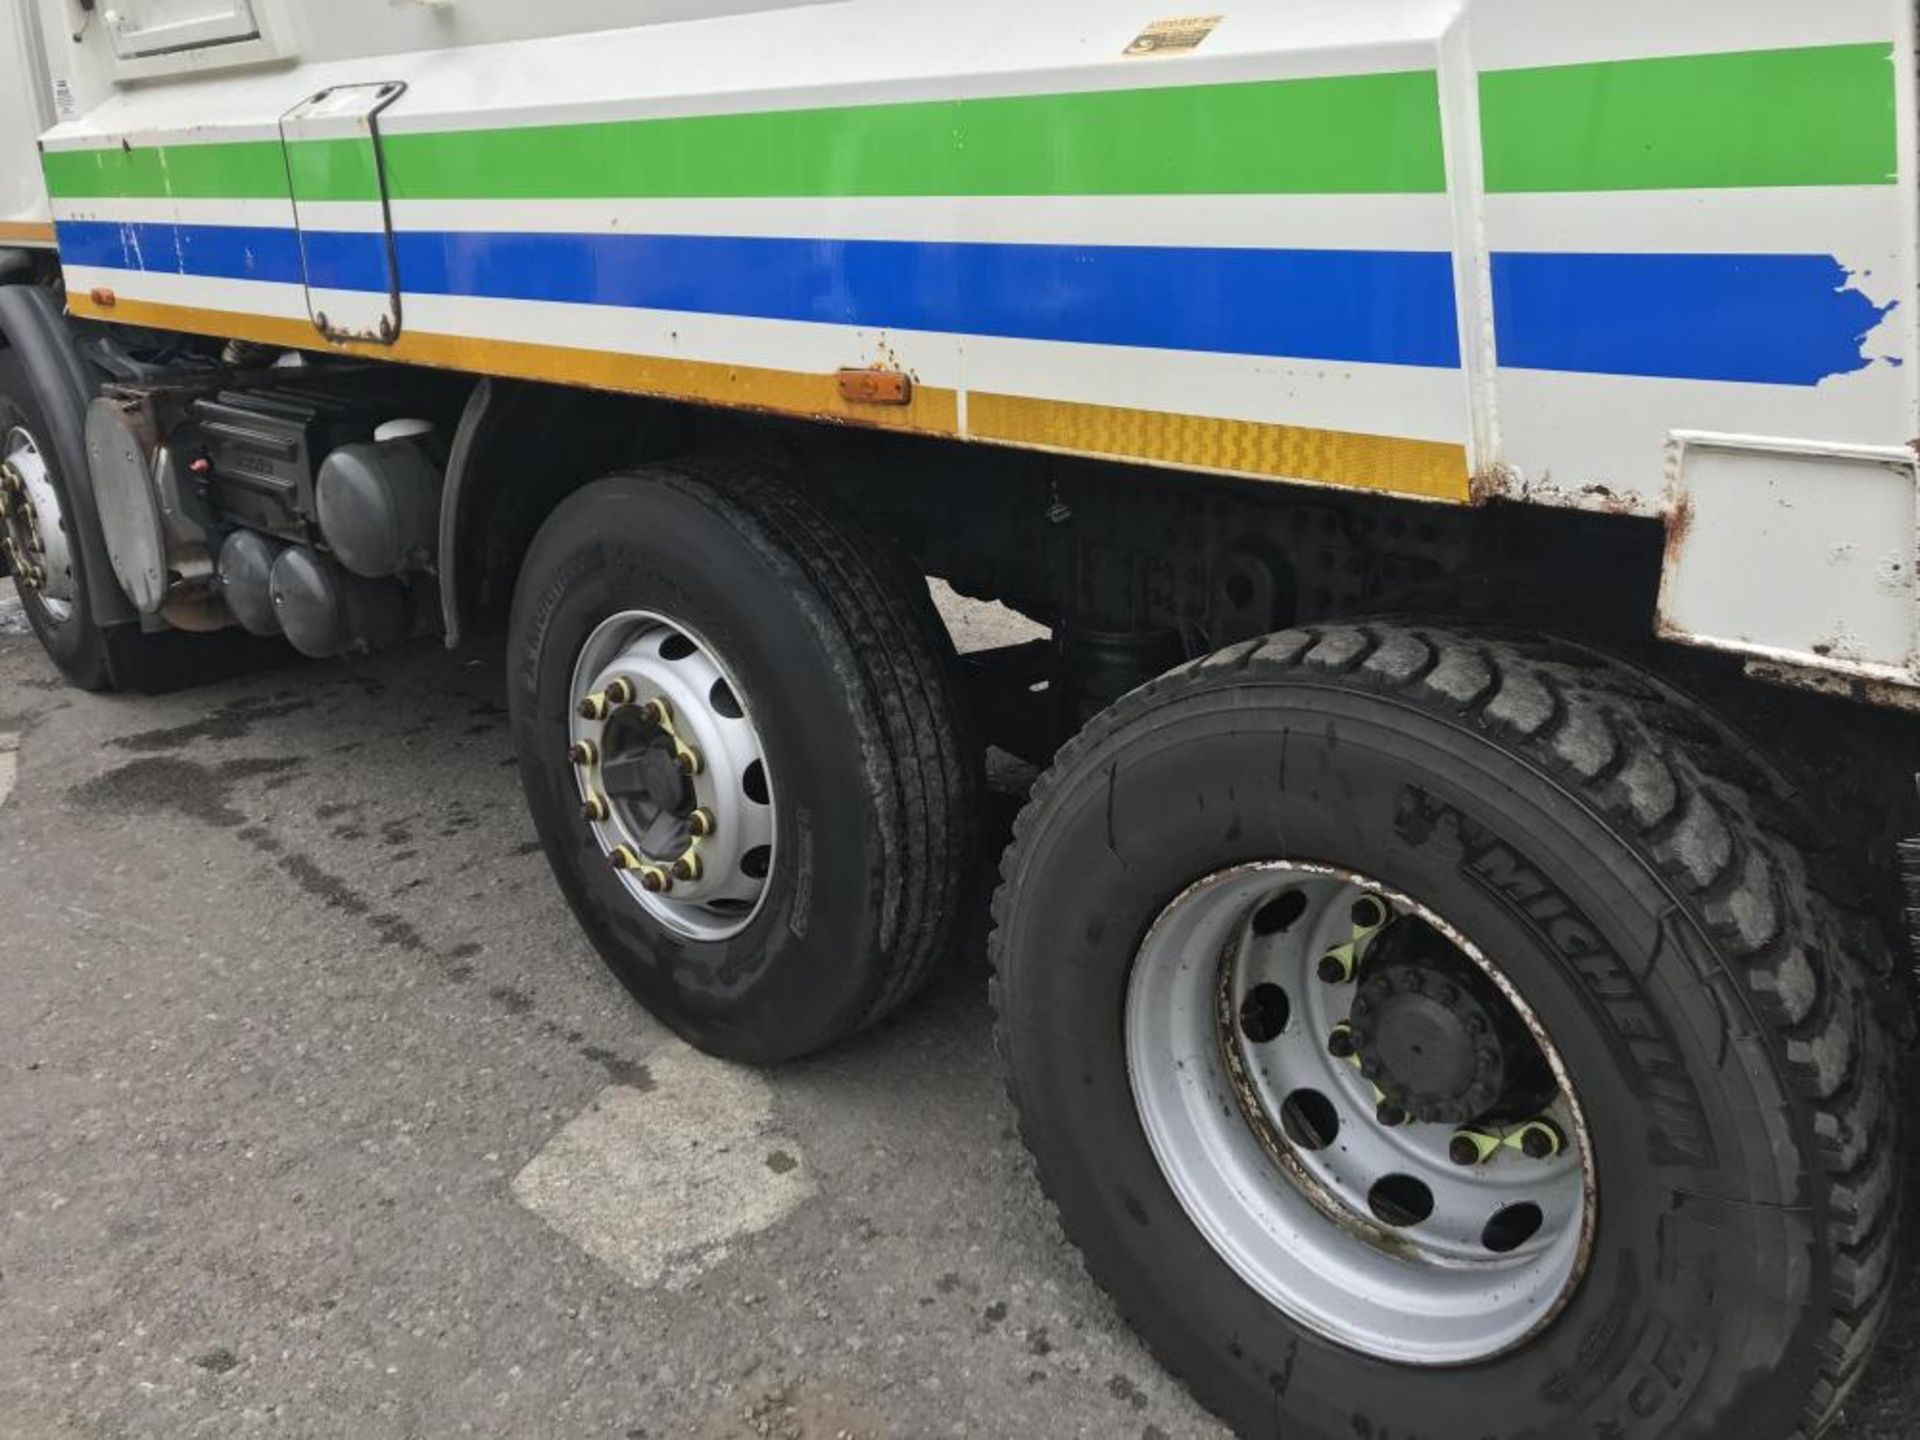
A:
[46,71,1446,200]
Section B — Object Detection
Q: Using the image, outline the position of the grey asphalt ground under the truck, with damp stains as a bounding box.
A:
[11,582,1920,1440]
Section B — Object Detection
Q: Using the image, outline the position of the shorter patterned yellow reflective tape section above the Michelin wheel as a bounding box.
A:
[966,392,1469,503]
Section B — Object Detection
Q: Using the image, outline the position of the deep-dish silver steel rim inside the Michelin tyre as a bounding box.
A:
[1125,862,1596,1365]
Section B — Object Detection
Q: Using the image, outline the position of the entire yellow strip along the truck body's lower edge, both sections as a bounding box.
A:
[67,290,1469,503]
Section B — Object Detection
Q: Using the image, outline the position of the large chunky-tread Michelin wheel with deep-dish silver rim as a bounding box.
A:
[995,626,1899,1440]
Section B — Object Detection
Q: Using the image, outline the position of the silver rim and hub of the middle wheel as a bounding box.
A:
[568,611,776,941]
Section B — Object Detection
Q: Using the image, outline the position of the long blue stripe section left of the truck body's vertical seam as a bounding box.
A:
[60,221,1459,369]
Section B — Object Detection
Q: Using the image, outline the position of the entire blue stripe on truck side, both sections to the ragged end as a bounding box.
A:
[60,221,1891,386]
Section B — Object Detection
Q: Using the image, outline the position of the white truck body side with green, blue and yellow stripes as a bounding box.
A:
[0,0,1920,687]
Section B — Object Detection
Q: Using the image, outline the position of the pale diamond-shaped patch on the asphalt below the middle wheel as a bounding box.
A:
[513,1044,814,1290]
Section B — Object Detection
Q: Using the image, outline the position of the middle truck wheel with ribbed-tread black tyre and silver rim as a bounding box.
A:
[511,463,979,1062]
